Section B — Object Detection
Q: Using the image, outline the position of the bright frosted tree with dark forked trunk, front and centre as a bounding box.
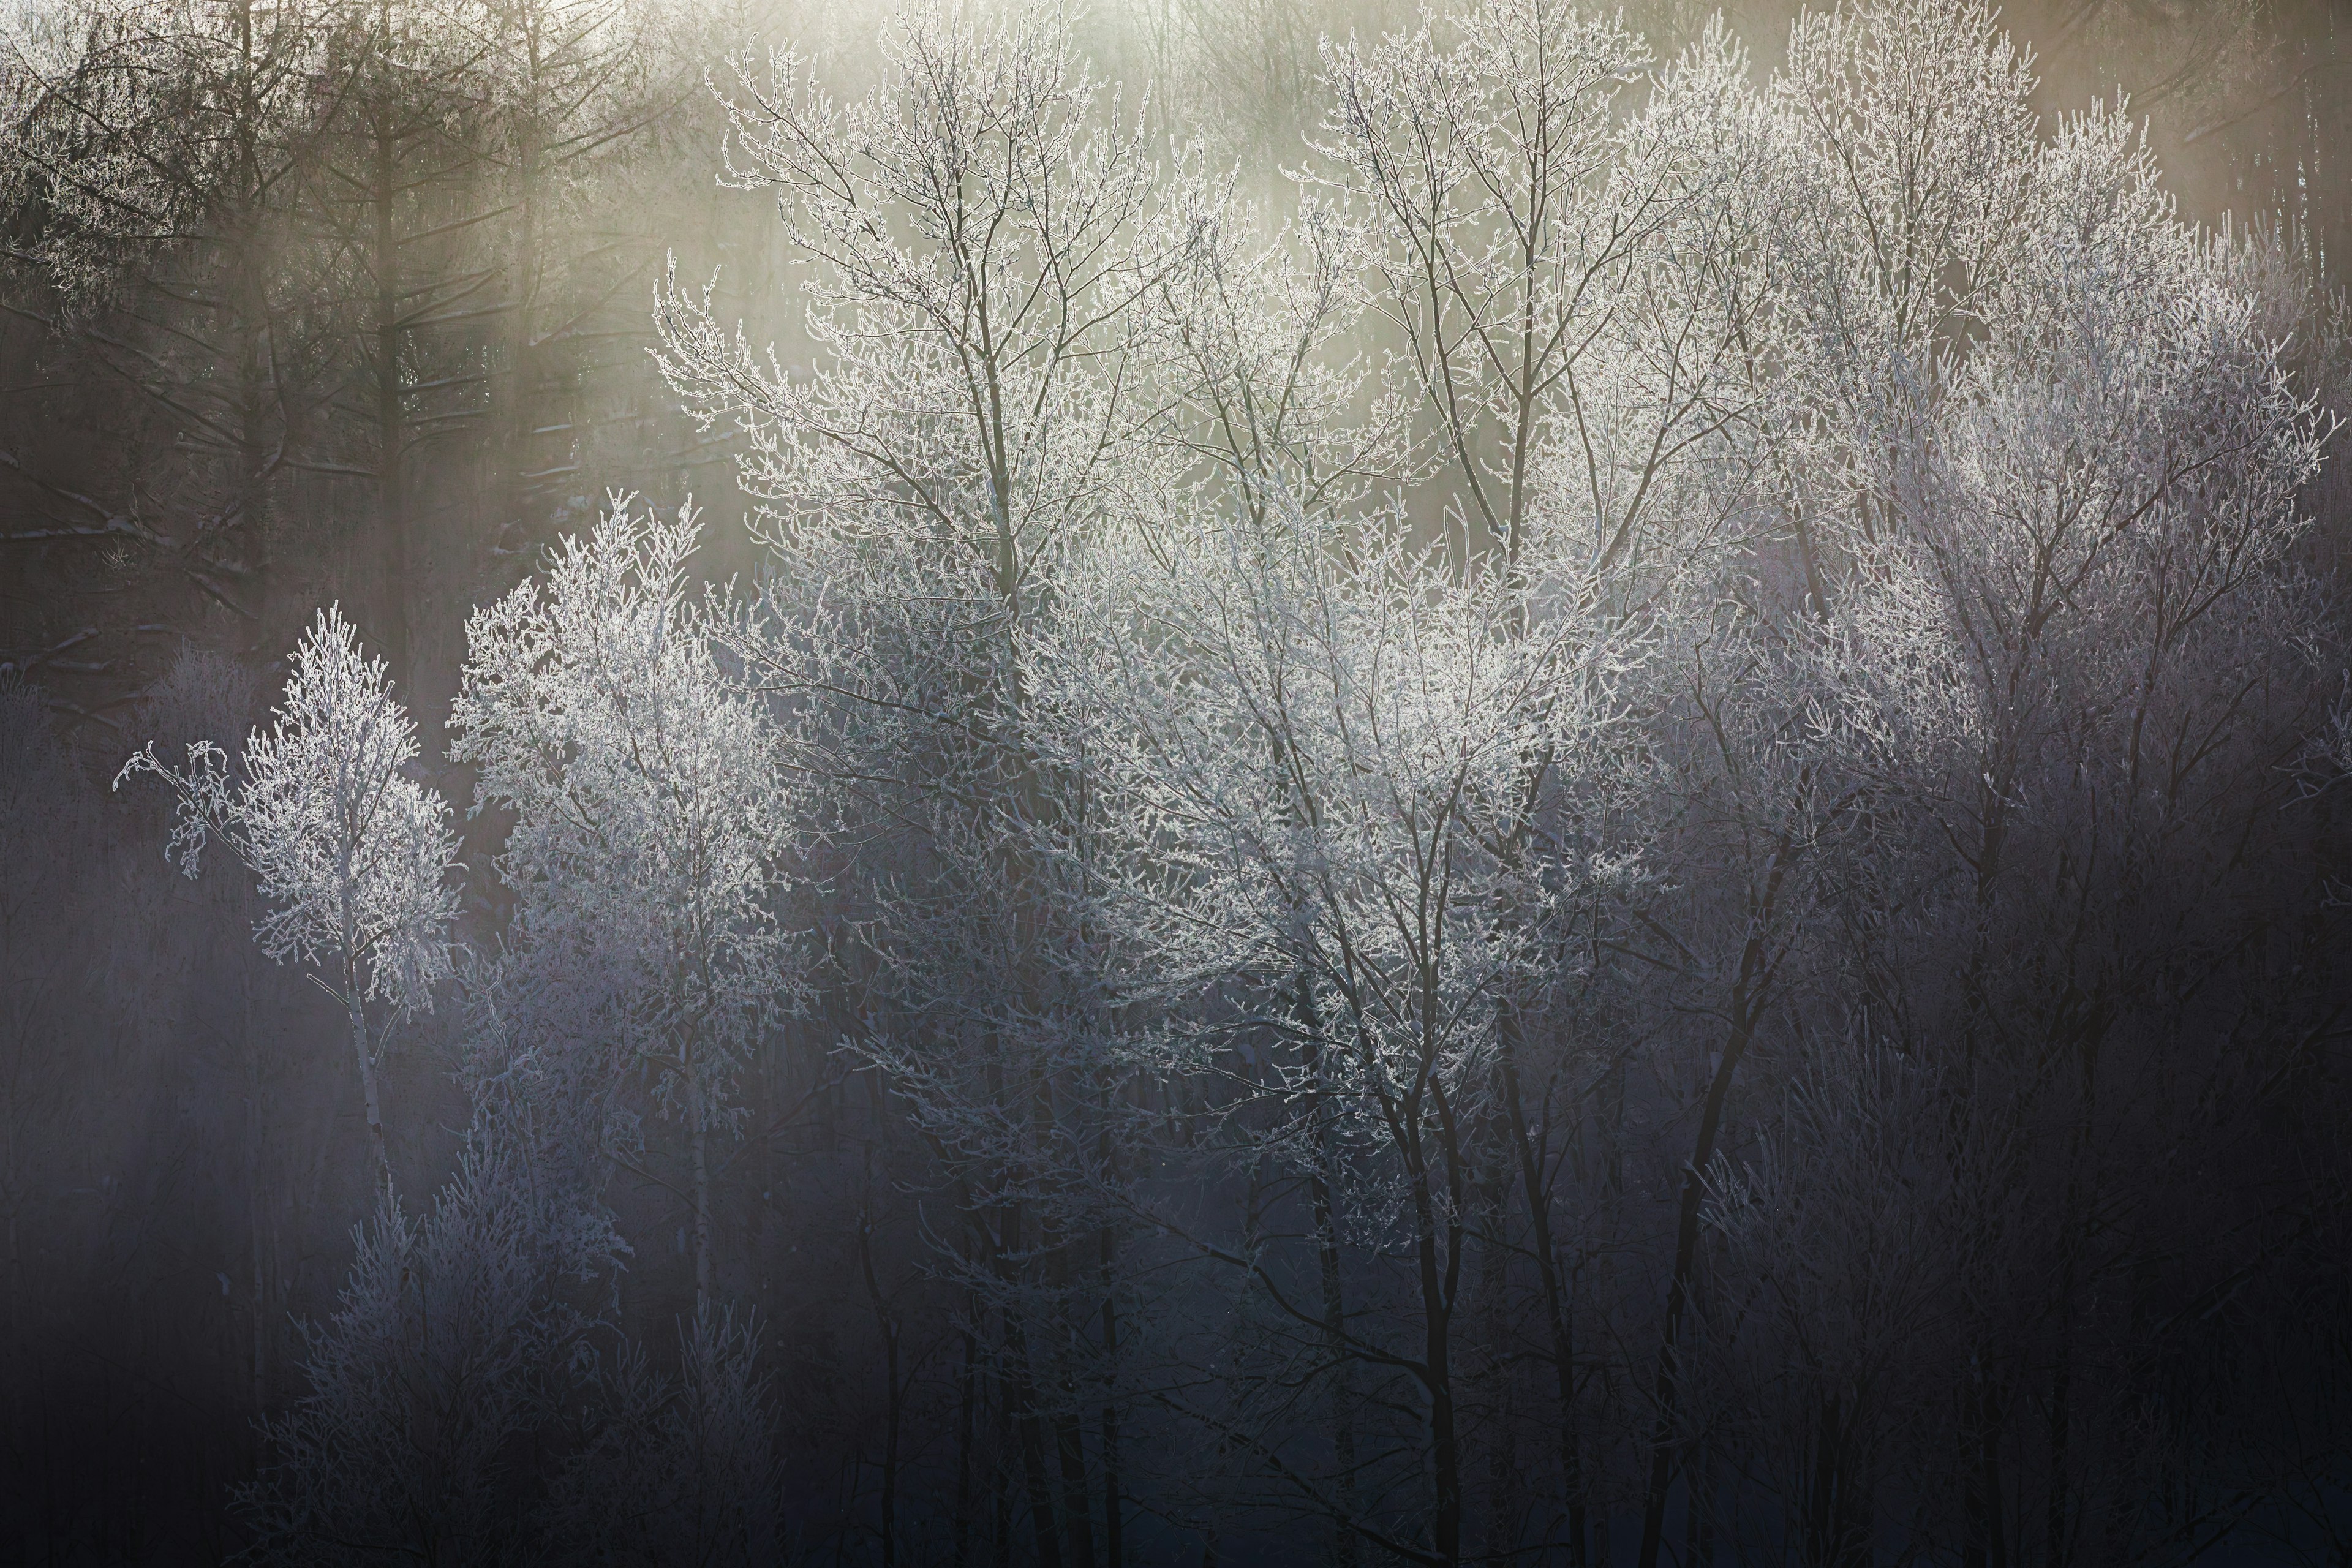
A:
[1056,496,1623,1561]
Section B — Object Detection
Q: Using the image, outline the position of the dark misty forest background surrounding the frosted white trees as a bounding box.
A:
[0,0,2352,1568]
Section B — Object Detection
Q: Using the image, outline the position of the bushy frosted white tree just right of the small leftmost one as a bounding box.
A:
[449,496,797,1295]
